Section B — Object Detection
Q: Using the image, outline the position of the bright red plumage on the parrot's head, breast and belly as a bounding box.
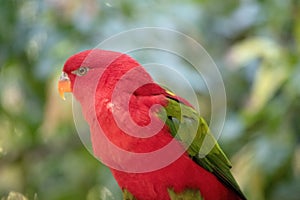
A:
[63,50,240,200]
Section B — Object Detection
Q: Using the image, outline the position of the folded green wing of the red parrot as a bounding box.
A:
[160,96,246,199]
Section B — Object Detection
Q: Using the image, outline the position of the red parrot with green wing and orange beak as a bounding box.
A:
[58,48,246,200]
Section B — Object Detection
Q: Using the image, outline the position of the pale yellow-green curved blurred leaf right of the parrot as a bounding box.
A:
[229,38,290,114]
